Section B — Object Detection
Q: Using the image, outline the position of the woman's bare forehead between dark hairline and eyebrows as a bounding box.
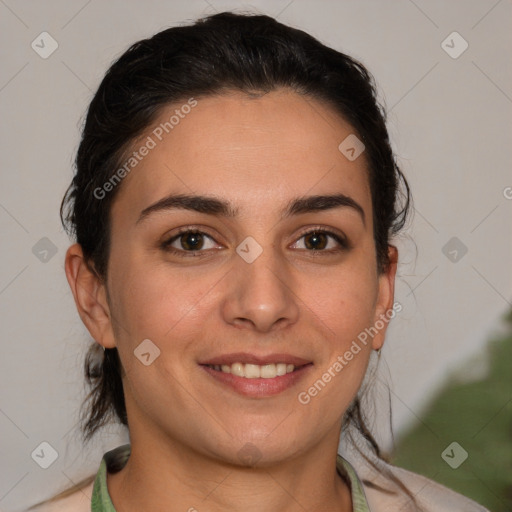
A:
[112,90,371,222]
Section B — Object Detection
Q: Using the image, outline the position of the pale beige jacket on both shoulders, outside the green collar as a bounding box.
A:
[28,460,489,512]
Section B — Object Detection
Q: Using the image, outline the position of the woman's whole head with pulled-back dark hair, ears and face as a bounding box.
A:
[62,9,408,461]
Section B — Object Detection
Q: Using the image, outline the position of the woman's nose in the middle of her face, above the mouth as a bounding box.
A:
[222,242,299,333]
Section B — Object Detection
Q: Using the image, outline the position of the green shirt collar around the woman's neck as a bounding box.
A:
[91,444,370,512]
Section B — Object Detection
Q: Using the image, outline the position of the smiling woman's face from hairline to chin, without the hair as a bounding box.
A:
[86,90,395,463]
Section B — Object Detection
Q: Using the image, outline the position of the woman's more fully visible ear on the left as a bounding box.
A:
[65,244,116,348]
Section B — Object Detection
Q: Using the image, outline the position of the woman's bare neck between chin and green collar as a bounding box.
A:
[107,435,352,512]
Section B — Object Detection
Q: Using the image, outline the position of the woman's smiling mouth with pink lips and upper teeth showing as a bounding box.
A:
[200,353,313,398]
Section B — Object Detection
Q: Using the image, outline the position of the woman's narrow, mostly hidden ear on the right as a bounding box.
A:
[372,245,398,350]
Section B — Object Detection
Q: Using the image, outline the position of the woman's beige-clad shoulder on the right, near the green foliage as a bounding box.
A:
[363,464,489,512]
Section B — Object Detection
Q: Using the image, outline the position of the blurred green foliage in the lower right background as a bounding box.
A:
[393,313,512,512]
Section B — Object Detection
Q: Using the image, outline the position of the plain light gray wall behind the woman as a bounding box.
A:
[0,0,512,511]
